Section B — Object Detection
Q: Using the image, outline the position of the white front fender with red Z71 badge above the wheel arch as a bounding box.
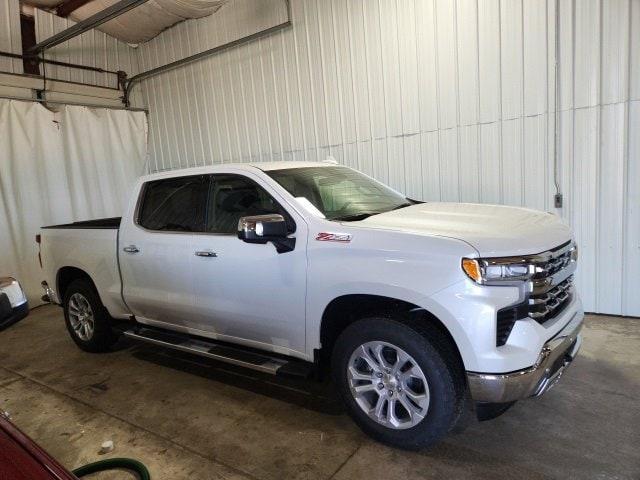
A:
[306,229,476,357]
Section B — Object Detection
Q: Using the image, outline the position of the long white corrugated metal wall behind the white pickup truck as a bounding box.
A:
[131,0,640,316]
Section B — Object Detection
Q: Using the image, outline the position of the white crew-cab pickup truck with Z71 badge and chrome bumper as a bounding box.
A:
[38,162,584,449]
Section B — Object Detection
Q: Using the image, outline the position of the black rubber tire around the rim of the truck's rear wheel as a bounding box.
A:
[62,279,118,353]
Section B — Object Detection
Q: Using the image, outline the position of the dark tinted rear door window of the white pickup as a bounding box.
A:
[138,175,209,232]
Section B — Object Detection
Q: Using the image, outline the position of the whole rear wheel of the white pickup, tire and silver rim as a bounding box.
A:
[63,279,118,352]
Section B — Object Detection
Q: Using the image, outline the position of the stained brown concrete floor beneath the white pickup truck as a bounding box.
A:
[0,306,640,480]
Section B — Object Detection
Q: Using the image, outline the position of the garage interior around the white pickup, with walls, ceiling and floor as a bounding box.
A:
[0,0,640,480]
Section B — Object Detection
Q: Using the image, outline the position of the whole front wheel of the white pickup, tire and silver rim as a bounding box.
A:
[332,317,464,450]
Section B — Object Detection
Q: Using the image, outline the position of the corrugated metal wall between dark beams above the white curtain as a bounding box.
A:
[33,8,139,88]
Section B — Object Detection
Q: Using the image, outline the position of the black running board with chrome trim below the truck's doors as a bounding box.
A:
[123,327,313,378]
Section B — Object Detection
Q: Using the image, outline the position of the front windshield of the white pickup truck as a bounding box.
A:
[265,166,413,221]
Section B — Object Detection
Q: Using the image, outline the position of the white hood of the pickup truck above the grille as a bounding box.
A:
[352,202,571,257]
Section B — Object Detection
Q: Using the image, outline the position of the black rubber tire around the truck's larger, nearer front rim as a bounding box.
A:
[331,317,466,450]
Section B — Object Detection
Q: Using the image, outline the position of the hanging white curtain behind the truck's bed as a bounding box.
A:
[0,99,147,305]
